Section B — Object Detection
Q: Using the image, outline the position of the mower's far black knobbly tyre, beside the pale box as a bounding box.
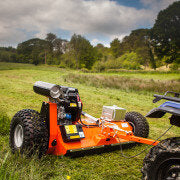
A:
[125,111,149,138]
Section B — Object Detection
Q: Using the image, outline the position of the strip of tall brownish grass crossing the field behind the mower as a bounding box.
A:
[65,74,180,93]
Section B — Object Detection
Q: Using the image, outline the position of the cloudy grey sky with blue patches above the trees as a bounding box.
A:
[0,0,176,47]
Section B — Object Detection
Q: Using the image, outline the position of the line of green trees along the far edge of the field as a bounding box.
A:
[0,1,180,71]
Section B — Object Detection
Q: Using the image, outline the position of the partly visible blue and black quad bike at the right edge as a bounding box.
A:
[141,92,180,180]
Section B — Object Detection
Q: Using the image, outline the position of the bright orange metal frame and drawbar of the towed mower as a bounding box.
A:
[47,102,159,155]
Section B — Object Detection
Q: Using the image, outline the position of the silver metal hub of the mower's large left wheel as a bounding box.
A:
[14,124,24,148]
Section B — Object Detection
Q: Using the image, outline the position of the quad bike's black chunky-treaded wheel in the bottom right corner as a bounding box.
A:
[141,137,180,180]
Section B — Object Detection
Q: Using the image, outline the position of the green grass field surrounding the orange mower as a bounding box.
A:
[0,63,180,180]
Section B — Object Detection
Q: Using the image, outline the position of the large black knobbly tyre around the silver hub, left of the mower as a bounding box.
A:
[9,109,49,157]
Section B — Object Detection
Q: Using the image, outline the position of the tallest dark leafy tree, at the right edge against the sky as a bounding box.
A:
[151,1,180,64]
